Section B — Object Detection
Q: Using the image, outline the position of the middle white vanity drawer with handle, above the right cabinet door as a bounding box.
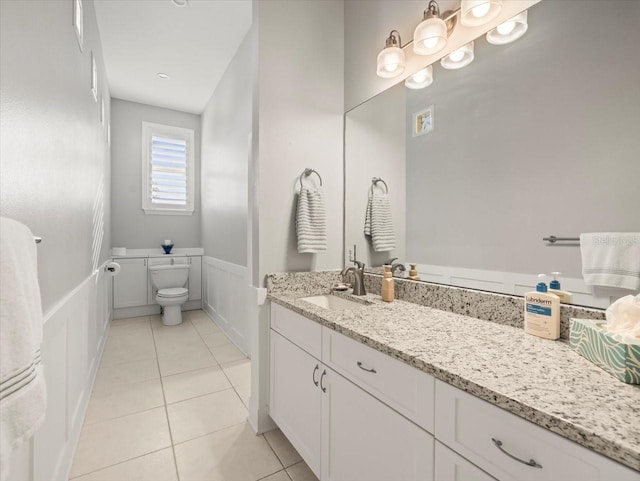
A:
[322,327,435,433]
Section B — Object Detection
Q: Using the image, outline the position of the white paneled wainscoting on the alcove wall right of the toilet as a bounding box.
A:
[202,256,250,356]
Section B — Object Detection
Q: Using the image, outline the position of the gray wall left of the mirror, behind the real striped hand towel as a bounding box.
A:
[254,0,344,279]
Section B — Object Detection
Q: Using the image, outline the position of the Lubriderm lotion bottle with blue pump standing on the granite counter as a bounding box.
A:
[524,274,560,339]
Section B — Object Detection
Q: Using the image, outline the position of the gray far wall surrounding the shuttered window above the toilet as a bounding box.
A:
[111,98,201,249]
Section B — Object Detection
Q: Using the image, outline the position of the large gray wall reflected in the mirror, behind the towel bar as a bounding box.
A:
[407,0,640,277]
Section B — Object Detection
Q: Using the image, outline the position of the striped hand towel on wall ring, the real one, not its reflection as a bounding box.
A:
[296,187,327,254]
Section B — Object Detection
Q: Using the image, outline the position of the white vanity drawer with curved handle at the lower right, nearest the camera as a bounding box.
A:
[436,380,639,481]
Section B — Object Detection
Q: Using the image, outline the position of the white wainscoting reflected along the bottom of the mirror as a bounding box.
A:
[416,264,630,308]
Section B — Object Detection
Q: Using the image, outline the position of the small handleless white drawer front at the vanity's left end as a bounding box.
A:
[271,302,322,359]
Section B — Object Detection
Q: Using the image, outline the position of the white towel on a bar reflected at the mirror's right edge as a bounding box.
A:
[580,232,640,291]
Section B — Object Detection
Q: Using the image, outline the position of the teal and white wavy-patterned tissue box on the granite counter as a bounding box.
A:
[570,319,640,384]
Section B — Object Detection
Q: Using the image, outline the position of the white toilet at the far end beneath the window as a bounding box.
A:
[149,264,189,326]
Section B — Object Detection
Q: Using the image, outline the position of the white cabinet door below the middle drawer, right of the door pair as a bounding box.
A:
[320,368,434,481]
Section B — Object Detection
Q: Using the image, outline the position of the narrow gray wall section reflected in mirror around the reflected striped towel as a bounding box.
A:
[344,84,407,266]
